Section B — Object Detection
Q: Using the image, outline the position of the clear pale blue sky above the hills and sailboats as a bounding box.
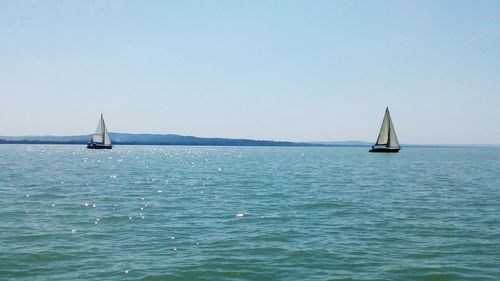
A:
[0,0,500,144]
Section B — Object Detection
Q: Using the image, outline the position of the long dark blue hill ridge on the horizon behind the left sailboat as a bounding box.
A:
[0,133,324,146]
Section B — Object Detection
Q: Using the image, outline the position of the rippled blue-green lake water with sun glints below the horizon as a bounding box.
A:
[0,145,500,280]
